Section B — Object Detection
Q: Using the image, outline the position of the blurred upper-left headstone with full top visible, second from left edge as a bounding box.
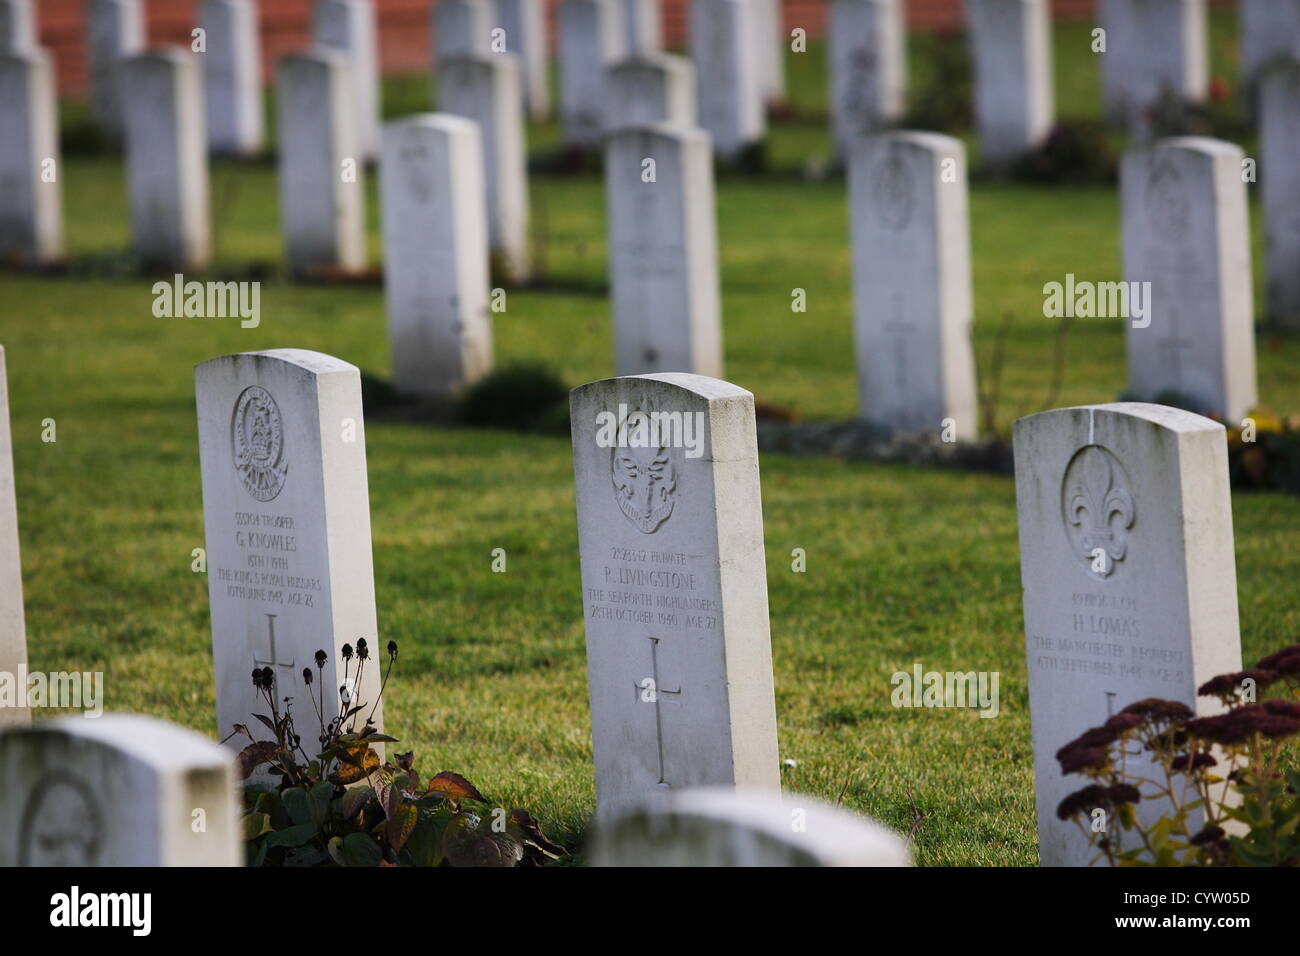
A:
[121,47,212,271]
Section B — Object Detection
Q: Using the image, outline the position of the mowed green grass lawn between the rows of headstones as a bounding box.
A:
[0,17,1300,865]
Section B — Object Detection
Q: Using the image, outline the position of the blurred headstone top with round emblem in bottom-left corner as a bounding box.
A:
[0,714,244,863]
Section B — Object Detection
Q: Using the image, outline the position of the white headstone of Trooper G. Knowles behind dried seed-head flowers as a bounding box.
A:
[194,349,385,756]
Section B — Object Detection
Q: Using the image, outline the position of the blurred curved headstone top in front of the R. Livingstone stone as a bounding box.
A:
[590,787,911,866]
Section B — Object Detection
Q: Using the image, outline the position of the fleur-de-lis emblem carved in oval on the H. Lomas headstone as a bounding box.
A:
[1063,445,1136,578]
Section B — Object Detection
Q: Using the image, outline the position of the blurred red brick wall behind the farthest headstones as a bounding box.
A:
[35,0,1232,94]
